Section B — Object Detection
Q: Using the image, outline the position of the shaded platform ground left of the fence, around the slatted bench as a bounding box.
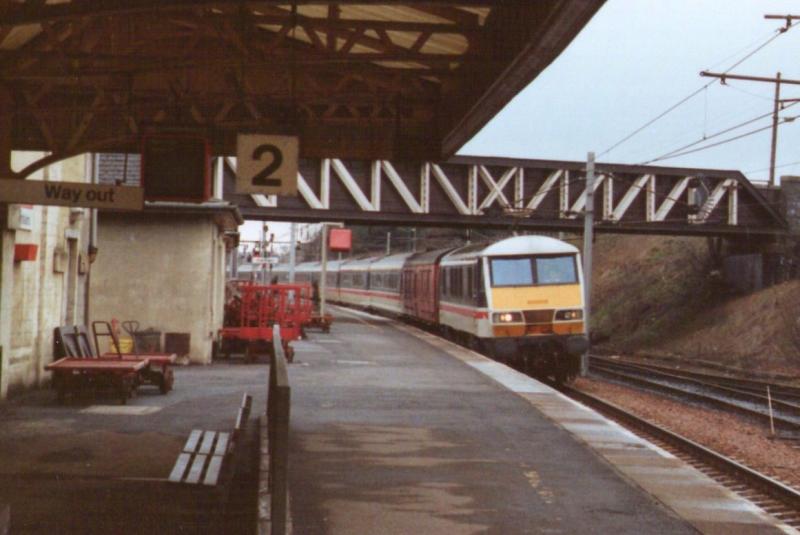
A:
[0,363,268,535]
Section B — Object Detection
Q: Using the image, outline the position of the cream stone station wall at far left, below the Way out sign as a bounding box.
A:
[0,152,91,399]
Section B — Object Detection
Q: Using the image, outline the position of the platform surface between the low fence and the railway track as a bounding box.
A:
[290,308,784,534]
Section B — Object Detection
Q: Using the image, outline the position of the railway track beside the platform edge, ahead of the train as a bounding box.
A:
[559,385,800,529]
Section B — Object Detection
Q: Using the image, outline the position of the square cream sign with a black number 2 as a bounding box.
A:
[236,134,299,195]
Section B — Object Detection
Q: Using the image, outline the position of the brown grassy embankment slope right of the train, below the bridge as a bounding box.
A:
[592,236,800,374]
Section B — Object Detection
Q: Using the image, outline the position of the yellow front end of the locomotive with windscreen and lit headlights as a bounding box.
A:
[482,236,588,377]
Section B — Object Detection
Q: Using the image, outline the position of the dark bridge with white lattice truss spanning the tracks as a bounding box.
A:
[222,157,786,236]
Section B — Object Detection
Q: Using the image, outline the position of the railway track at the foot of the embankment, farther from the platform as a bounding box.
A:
[590,357,800,439]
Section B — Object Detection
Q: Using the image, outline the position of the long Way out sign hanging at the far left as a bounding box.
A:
[0,179,144,210]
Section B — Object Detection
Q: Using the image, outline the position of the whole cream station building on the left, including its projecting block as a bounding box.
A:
[0,152,243,399]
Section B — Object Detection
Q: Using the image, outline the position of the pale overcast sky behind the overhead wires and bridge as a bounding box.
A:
[243,0,800,239]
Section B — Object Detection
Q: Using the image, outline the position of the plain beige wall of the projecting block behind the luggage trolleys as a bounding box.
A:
[89,213,225,364]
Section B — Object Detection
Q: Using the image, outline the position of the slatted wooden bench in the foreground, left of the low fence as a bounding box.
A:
[169,394,253,487]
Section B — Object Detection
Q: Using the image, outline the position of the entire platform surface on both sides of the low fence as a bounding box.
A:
[0,308,792,535]
